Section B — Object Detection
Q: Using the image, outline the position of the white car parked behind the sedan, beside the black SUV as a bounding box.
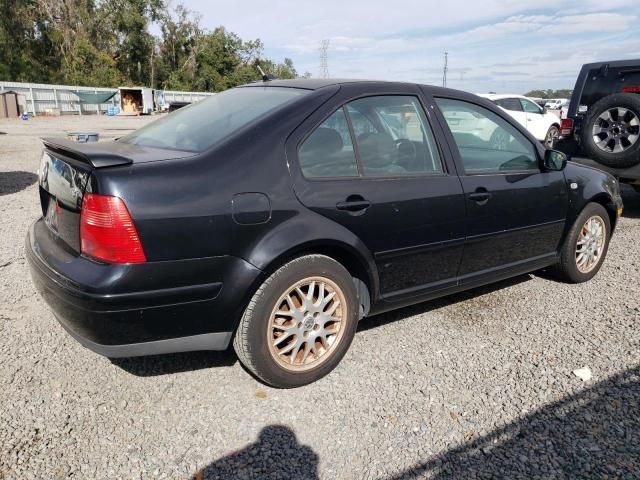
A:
[479,93,560,148]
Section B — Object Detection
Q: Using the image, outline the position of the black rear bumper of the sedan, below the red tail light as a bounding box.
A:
[26,220,262,357]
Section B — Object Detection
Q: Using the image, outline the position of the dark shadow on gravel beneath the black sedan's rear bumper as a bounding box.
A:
[111,349,238,377]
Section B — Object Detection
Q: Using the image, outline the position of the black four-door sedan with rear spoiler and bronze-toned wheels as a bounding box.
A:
[26,80,622,387]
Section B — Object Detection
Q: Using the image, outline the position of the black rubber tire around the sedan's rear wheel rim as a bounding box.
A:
[233,255,358,388]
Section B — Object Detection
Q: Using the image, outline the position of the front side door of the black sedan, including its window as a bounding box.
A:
[436,97,568,284]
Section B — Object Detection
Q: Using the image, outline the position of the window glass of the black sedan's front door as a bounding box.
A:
[436,98,538,174]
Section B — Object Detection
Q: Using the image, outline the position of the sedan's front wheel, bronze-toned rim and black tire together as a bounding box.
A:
[556,203,611,283]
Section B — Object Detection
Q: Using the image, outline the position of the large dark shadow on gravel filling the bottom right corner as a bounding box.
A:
[386,367,640,480]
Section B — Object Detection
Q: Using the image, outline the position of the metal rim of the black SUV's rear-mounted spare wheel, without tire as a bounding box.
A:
[591,107,640,153]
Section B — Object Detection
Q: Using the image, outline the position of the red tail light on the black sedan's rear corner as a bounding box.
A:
[80,193,147,263]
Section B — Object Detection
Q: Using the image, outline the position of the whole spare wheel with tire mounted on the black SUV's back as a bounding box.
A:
[582,93,640,168]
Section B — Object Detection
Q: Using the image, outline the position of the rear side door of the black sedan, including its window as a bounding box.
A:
[287,84,465,300]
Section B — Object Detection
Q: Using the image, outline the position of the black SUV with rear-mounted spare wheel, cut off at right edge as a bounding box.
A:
[556,59,640,192]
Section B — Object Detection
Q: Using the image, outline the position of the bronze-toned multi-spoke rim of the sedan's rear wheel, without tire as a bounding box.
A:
[267,277,348,372]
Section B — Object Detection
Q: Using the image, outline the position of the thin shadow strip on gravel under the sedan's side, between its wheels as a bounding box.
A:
[358,273,537,332]
